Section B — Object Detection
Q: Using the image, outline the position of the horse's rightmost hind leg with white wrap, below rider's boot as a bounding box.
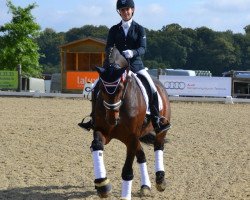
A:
[154,133,167,192]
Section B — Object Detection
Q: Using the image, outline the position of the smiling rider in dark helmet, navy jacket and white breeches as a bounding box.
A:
[79,0,168,133]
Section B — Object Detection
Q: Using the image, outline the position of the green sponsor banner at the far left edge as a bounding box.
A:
[0,71,18,90]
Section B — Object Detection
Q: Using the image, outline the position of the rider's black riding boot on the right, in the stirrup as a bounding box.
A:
[150,92,170,134]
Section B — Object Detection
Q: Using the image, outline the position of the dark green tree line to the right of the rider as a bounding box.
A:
[144,24,250,76]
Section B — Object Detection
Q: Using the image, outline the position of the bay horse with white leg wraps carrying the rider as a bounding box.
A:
[91,47,170,199]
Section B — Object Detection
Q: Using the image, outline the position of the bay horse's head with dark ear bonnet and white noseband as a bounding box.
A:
[96,64,127,125]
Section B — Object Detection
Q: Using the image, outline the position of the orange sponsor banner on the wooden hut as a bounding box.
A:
[66,72,99,90]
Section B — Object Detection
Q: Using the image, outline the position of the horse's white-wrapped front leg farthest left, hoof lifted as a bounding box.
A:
[90,131,111,198]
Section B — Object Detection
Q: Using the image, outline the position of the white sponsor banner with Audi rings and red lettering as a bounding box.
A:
[159,75,231,97]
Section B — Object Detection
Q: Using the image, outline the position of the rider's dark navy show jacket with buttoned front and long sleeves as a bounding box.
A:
[106,21,146,73]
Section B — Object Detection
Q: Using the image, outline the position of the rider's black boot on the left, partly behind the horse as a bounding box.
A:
[78,83,99,131]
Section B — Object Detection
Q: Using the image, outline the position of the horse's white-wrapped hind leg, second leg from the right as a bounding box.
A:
[136,145,151,197]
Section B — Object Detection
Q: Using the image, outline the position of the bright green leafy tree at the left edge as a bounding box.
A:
[0,0,42,77]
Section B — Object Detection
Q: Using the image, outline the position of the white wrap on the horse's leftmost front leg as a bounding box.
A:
[92,151,106,179]
